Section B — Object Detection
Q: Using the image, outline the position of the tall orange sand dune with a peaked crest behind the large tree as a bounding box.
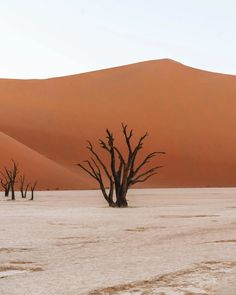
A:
[0,60,236,188]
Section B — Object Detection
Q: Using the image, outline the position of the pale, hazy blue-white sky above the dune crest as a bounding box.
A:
[0,0,236,78]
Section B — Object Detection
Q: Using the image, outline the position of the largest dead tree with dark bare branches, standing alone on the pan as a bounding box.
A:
[77,124,165,207]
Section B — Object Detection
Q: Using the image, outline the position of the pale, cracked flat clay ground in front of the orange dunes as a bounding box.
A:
[0,188,236,295]
